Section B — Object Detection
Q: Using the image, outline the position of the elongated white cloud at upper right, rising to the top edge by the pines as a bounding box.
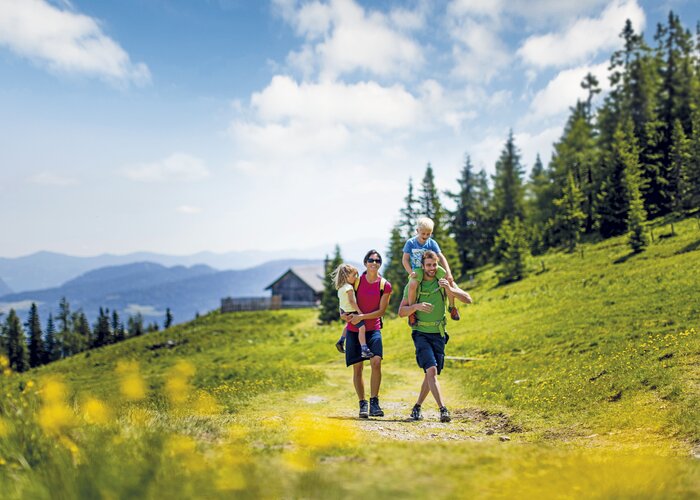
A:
[517,0,645,68]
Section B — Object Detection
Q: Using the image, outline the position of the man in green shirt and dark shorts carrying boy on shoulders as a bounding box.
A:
[399,250,472,422]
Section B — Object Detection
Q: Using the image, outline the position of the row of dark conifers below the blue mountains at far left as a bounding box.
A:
[0,297,173,372]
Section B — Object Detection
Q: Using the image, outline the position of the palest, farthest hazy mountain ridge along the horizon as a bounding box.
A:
[0,239,386,296]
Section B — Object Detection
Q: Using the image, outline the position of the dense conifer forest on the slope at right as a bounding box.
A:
[384,12,700,298]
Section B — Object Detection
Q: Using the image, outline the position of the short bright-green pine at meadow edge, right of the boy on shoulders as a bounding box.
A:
[494,218,530,284]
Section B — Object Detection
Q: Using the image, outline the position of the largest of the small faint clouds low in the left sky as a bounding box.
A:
[123,153,209,182]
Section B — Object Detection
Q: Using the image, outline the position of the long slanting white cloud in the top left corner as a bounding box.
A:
[0,0,151,85]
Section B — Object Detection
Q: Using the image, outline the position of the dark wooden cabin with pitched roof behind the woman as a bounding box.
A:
[265,265,323,308]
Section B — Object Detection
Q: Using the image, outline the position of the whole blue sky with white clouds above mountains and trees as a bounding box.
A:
[0,0,700,257]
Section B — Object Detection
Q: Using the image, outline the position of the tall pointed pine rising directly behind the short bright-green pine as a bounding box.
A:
[493,130,525,226]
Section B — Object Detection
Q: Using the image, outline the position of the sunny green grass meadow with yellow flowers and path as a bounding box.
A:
[0,219,700,499]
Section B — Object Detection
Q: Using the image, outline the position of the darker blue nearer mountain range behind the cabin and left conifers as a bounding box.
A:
[0,259,323,323]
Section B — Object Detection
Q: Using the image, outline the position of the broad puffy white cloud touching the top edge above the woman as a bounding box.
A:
[276,0,424,80]
